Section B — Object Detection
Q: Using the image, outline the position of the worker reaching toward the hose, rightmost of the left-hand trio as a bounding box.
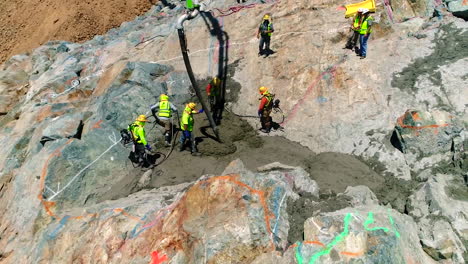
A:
[179,102,203,156]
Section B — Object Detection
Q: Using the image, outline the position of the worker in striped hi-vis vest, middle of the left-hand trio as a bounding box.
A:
[151,94,177,147]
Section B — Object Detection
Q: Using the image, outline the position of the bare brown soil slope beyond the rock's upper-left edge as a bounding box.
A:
[0,0,157,63]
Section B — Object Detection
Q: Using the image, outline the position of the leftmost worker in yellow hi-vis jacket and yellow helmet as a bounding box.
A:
[128,115,151,166]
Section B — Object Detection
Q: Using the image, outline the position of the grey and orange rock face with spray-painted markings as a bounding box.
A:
[0,0,468,263]
